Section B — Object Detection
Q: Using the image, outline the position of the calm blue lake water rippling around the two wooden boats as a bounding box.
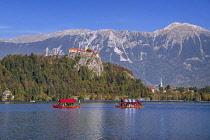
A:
[0,102,210,140]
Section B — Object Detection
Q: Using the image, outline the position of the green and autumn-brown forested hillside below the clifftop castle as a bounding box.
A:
[0,53,151,101]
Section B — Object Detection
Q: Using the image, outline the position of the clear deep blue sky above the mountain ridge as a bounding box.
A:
[0,0,210,39]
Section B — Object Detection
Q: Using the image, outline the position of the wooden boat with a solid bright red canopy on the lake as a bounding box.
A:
[52,99,82,108]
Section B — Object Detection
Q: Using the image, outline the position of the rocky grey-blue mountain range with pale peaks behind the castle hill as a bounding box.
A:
[0,22,210,86]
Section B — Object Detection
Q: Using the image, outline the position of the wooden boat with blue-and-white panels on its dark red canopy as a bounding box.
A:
[115,99,144,108]
